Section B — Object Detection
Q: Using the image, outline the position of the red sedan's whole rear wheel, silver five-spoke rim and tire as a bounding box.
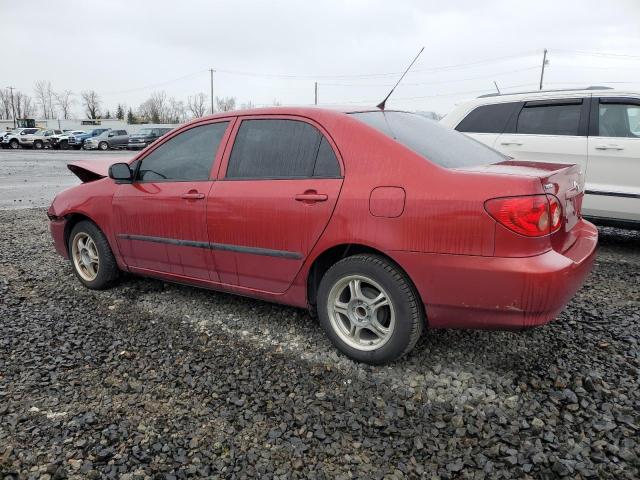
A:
[317,255,425,364]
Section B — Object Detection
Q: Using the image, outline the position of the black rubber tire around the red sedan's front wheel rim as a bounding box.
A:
[67,220,120,290]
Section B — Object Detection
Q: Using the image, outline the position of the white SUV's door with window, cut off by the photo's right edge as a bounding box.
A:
[583,97,640,222]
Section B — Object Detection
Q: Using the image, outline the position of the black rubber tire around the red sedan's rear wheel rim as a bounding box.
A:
[317,254,426,365]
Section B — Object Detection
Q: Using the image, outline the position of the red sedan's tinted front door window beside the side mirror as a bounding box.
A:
[136,122,229,182]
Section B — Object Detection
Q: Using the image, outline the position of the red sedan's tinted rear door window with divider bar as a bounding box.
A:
[226,119,340,179]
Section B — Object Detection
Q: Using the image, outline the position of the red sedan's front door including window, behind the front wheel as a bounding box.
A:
[113,119,231,281]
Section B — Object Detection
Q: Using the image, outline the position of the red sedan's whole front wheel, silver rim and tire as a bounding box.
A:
[69,220,120,290]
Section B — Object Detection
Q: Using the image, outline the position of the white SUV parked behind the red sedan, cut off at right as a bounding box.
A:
[441,87,640,228]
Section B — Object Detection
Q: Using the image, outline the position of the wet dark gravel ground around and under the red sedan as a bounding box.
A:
[0,209,640,479]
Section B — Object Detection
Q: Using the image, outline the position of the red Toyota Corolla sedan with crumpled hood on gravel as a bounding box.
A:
[48,108,597,364]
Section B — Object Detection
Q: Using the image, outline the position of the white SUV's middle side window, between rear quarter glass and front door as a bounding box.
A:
[516,101,582,135]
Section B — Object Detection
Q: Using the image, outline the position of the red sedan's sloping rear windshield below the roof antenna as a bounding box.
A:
[351,111,507,168]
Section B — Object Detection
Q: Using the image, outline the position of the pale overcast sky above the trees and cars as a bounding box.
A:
[0,0,640,114]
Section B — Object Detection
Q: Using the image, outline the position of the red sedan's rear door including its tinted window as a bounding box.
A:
[207,116,342,293]
